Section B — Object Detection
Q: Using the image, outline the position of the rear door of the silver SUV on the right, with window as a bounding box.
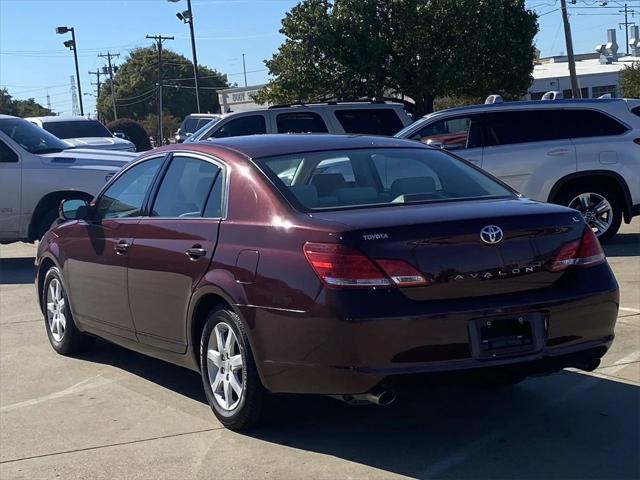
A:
[482,109,577,198]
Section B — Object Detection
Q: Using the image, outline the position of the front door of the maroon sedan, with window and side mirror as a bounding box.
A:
[64,157,163,339]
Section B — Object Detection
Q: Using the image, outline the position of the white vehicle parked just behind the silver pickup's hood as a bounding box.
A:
[25,116,136,152]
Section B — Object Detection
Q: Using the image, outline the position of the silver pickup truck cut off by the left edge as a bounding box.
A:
[0,115,135,243]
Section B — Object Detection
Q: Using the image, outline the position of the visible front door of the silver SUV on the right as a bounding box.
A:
[409,114,482,166]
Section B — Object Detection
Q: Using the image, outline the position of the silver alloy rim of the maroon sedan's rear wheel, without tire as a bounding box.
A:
[207,322,245,411]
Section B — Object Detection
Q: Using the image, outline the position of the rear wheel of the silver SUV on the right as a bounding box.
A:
[557,184,622,243]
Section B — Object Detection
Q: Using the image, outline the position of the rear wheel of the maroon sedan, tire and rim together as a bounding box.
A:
[200,308,268,430]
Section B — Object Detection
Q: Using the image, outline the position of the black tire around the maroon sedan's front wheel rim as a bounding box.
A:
[42,267,95,355]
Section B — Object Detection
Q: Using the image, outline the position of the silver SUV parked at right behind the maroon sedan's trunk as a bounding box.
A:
[396,99,640,242]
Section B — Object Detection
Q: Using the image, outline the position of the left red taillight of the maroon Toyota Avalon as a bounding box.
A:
[304,242,427,288]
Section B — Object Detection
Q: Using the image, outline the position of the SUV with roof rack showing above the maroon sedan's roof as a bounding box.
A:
[188,101,412,142]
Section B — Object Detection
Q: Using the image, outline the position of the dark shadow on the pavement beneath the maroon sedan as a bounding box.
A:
[81,340,640,480]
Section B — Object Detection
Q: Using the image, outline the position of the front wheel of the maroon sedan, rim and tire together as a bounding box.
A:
[42,267,95,355]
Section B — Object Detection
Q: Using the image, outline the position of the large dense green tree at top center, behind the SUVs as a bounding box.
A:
[257,0,538,115]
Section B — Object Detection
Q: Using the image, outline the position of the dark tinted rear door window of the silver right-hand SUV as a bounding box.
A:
[484,109,573,146]
